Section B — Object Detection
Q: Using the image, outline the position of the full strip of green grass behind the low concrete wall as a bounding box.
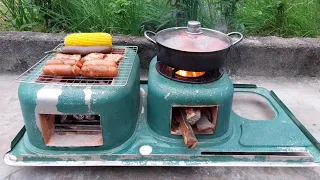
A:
[0,0,320,37]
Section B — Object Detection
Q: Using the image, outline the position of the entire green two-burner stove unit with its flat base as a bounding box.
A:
[4,46,320,166]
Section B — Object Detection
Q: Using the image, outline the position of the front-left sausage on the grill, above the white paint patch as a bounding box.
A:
[42,64,81,76]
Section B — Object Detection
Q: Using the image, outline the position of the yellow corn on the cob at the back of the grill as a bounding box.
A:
[64,33,112,47]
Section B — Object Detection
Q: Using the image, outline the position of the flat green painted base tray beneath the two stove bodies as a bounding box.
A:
[6,85,320,166]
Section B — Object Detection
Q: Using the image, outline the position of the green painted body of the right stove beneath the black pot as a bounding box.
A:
[147,59,233,138]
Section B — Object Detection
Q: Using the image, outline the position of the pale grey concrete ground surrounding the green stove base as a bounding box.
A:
[0,75,320,180]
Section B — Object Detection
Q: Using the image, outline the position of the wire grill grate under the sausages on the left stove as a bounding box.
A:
[16,46,138,86]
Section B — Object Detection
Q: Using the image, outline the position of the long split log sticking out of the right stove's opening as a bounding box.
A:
[175,111,198,149]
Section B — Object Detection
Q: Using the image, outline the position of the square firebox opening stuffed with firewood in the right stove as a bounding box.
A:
[170,106,218,135]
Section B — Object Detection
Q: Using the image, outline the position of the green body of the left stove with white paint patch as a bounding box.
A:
[19,56,140,150]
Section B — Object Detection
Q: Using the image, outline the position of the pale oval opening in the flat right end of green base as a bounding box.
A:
[232,92,276,120]
